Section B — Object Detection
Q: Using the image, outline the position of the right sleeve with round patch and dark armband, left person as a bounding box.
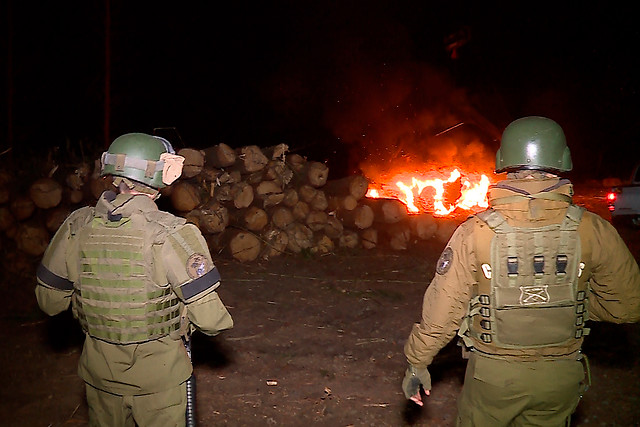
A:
[162,224,233,335]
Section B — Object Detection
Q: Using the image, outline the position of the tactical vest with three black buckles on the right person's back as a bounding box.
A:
[459,205,588,357]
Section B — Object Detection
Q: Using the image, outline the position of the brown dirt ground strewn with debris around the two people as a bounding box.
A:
[0,186,640,427]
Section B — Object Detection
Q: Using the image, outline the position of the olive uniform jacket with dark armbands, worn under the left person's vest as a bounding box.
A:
[35,192,233,395]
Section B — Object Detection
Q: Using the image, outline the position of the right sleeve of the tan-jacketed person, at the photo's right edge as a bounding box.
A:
[589,215,640,323]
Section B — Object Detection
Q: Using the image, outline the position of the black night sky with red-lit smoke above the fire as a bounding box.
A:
[0,0,640,177]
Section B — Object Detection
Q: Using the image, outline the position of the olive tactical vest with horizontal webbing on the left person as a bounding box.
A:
[72,213,180,344]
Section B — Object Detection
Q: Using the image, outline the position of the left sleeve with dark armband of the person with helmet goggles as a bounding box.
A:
[35,211,77,316]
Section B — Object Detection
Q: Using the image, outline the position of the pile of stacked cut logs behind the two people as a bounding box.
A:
[0,143,458,262]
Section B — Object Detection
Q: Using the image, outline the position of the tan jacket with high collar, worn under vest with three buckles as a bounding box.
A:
[404,177,640,368]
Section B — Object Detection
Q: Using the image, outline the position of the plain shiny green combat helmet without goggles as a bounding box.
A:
[496,116,573,173]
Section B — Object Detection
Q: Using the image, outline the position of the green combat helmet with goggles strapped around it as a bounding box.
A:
[100,133,184,190]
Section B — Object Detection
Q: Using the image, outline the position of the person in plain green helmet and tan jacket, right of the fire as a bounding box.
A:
[402,117,640,427]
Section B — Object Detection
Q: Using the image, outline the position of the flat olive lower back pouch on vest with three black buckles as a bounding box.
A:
[495,304,576,348]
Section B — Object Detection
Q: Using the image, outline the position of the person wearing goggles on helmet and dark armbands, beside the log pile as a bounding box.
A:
[36,133,233,426]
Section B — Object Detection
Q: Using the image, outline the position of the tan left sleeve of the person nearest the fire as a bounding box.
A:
[404,221,475,368]
